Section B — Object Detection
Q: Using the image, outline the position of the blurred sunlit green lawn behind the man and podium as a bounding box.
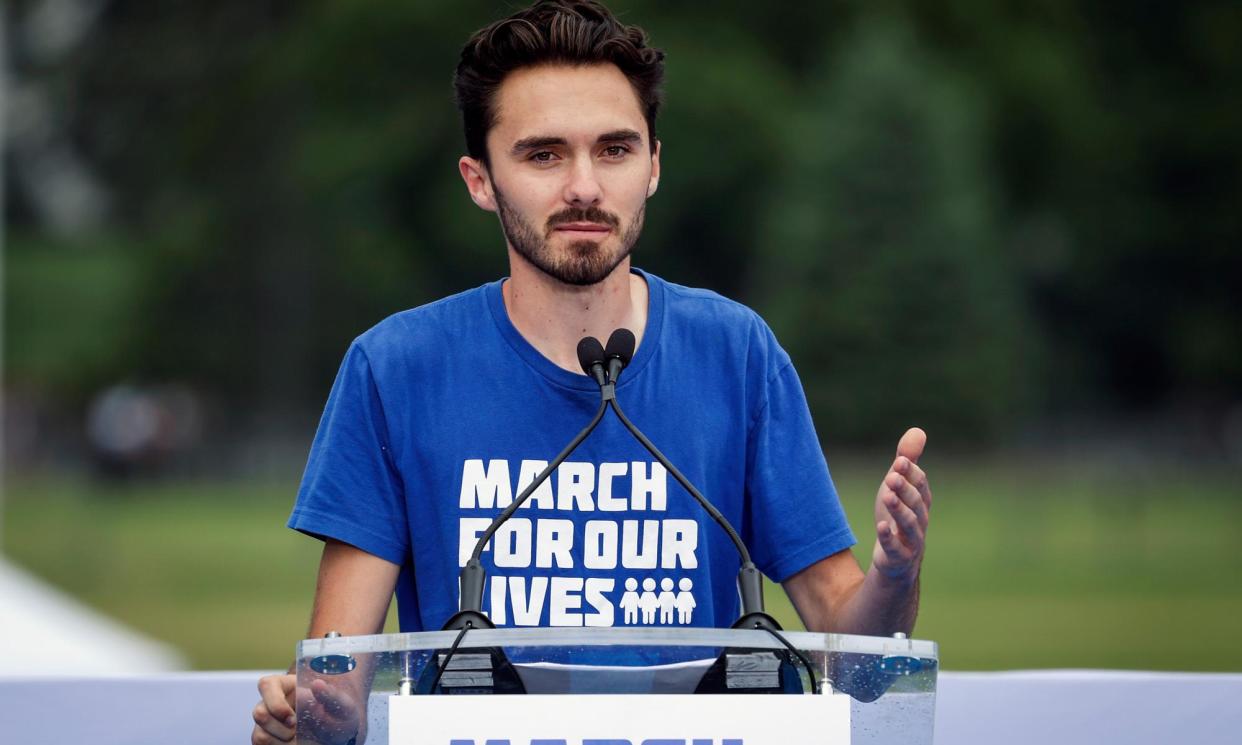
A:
[2,459,1242,671]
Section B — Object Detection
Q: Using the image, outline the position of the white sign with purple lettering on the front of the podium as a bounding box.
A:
[389,693,850,745]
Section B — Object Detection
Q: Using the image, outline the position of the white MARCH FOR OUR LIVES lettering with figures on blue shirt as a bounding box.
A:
[457,458,699,625]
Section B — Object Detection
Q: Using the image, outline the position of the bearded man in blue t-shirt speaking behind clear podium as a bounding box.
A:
[252,0,932,745]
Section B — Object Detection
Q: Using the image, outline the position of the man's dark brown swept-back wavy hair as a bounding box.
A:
[453,0,664,163]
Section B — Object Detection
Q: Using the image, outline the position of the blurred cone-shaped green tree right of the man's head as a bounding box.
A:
[755,17,1032,442]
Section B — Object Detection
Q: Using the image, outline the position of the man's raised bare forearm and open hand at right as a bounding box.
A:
[784,428,932,636]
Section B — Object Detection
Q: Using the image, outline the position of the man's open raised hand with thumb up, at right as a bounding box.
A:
[872,427,932,581]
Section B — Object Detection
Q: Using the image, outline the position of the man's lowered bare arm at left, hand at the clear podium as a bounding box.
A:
[251,539,401,745]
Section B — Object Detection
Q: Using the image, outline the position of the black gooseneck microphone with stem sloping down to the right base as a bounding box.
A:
[591,329,780,631]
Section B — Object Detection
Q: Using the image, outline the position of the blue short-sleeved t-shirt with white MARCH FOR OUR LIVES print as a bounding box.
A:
[288,272,854,631]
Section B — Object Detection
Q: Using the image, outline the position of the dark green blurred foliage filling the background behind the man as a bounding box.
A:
[4,0,1242,667]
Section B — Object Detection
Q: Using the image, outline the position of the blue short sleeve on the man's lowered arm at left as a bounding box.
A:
[288,341,409,564]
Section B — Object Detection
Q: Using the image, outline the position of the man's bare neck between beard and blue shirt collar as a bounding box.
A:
[502,248,647,373]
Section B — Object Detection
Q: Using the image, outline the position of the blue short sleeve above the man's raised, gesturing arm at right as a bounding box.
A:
[746,355,856,582]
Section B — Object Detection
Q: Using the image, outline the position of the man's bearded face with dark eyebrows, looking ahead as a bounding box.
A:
[462,65,660,286]
